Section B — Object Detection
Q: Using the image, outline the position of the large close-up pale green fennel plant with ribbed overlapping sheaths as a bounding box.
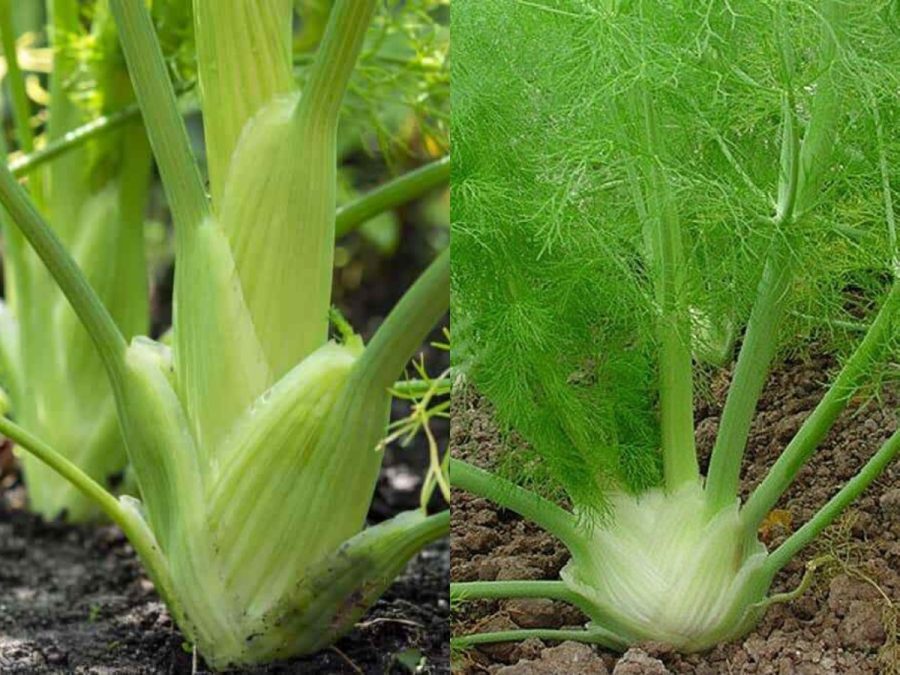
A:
[0,0,449,668]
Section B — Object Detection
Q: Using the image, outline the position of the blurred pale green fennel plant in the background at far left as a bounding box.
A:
[0,0,158,521]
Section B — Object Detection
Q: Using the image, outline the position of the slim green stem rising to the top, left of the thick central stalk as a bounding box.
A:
[110,0,210,235]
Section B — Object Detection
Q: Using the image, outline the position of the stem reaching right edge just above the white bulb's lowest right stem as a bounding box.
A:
[741,281,900,536]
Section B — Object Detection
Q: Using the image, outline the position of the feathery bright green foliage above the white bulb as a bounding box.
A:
[452,0,898,503]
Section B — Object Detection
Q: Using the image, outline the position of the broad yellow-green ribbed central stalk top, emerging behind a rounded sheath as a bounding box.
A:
[194,0,295,206]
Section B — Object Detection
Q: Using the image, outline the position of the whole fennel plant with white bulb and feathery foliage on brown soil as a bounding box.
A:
[450,0,900,651]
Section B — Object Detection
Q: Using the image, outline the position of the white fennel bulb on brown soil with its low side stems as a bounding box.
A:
[451,460,900,653]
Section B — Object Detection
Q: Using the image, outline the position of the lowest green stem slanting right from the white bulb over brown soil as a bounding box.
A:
[765,430,900,574]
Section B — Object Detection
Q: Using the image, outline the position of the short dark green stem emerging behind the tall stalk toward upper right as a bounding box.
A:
[335,156,450,237]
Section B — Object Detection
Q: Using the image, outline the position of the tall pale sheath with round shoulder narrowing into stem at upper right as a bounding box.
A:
[211,0,375,385]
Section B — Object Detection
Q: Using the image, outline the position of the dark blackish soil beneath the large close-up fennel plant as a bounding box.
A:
[0,500,449,675]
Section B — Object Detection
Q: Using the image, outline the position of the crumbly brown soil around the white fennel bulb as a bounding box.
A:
[451,357,900,675]
